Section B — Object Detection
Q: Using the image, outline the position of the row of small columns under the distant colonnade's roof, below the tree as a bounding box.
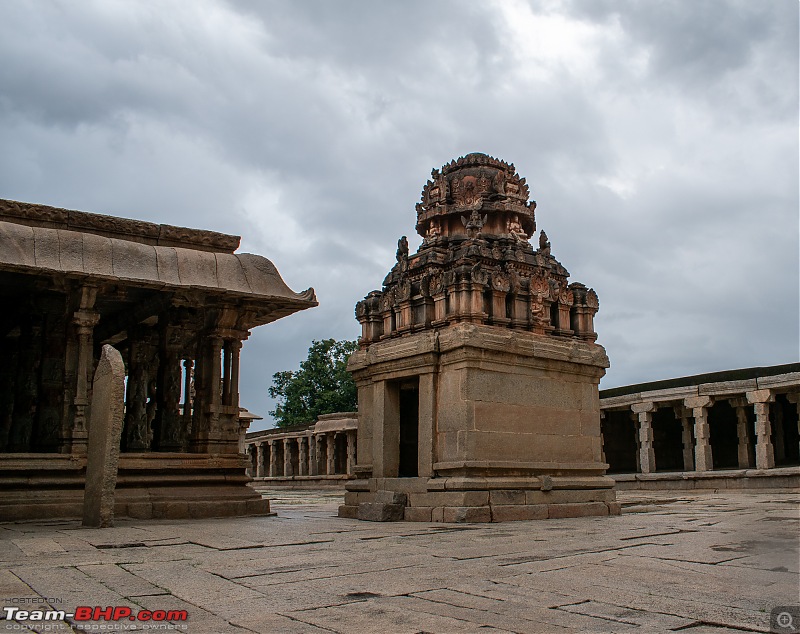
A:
[252,430,356,478]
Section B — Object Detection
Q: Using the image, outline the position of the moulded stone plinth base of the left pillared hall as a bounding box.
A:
[0,453,271,521]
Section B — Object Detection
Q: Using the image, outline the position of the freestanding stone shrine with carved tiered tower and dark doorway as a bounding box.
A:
[339,153,619,522]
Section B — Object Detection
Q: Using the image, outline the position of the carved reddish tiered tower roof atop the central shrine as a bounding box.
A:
[356,153,599,347]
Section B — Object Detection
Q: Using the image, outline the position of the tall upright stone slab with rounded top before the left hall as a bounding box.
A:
[83,344,125,528]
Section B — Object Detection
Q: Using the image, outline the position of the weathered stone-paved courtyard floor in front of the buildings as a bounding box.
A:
[0,490,800,634]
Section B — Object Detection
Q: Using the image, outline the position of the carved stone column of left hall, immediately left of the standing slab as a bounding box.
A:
[72,286,100,454]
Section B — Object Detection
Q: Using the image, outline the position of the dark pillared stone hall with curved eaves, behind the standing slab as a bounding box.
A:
[0,200,317,520]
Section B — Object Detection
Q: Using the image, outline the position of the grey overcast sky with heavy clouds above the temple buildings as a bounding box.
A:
[0,0,800,428]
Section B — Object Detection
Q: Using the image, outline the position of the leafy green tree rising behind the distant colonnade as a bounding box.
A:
[269,339,358,427]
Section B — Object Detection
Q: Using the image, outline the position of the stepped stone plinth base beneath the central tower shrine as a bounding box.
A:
[339,475,620,522]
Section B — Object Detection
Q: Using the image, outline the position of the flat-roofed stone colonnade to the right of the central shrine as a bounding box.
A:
[600,364,800,474]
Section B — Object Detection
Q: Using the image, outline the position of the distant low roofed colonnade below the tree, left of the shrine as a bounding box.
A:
[245,412,358,478]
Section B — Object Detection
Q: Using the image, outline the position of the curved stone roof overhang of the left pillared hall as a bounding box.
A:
[0,201,317,328]
